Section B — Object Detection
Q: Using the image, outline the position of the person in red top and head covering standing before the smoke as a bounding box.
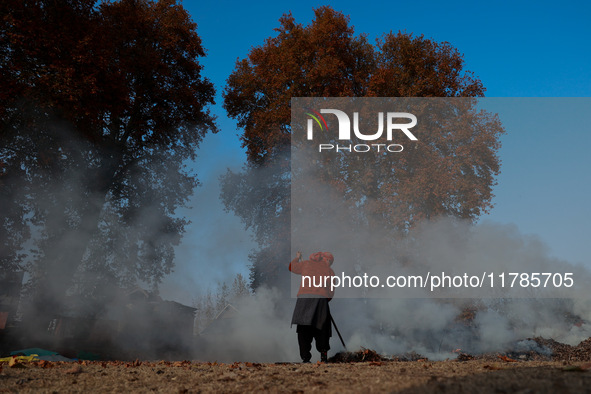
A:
[289,252,334,363]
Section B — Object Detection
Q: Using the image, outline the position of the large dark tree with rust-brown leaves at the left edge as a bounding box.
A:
[0,0,216,326]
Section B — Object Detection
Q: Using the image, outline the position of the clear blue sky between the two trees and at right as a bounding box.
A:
[163,0,591,302]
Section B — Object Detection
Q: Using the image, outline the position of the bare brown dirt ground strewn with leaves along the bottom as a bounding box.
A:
[0,358,591,393]
